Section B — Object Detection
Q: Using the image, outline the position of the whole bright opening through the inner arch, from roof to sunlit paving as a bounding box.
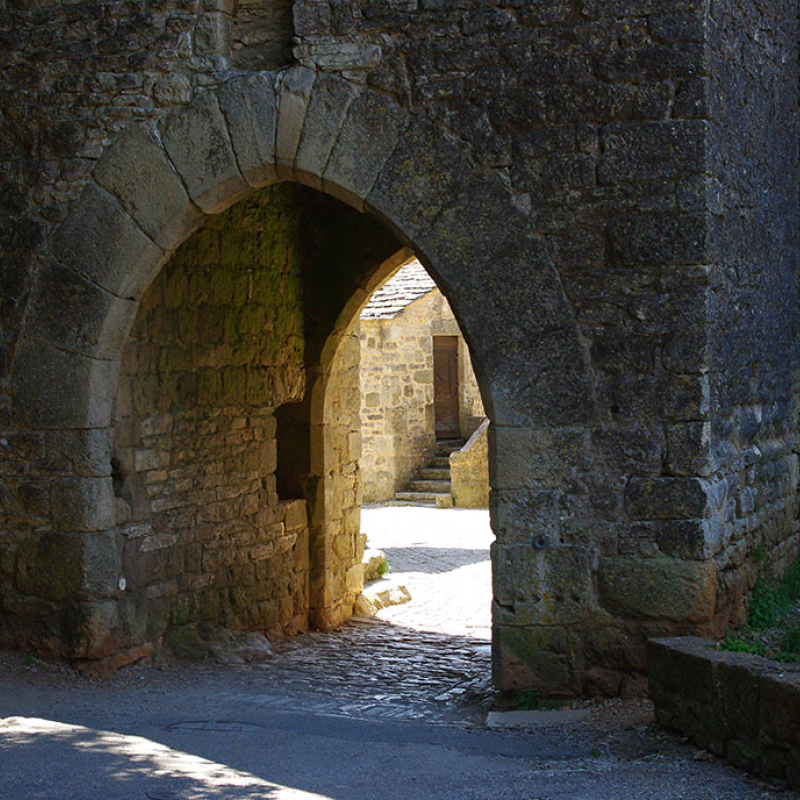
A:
[356,259,494,673]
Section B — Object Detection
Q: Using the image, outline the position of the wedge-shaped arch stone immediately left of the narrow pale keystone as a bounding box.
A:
[217,72,278,188]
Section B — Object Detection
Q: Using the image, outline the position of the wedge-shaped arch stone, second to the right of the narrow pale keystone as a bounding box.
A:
[322,90,409,211]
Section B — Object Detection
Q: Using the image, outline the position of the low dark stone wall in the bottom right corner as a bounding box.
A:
[648,637,800,789]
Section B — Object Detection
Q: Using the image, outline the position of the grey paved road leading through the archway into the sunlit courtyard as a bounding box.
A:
[0,509,795,800]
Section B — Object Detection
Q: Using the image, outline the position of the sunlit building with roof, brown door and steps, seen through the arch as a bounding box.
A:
[358,258,489,508]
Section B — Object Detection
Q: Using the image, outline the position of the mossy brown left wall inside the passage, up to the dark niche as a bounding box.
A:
[112,187,309,644]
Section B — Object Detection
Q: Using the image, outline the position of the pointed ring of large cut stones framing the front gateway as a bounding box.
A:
[6,68,594,684]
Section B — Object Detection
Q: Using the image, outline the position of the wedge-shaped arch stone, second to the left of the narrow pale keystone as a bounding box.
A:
[159,92,251,214]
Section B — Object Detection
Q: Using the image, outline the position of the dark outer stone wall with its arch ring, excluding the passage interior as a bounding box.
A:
[0,0,798,693]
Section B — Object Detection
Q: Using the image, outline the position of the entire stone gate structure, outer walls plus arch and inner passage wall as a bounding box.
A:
[0,0,799,694]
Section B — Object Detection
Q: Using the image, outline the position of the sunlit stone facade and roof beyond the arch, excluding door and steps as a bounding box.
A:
[359,259,485,503]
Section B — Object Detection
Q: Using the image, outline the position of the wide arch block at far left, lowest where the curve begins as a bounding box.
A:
[12,340,119,428]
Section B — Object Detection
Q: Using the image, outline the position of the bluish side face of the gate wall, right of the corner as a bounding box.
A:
[704,0,800,633]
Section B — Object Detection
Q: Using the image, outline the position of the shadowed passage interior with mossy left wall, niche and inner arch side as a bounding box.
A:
[113,184,400,645]
